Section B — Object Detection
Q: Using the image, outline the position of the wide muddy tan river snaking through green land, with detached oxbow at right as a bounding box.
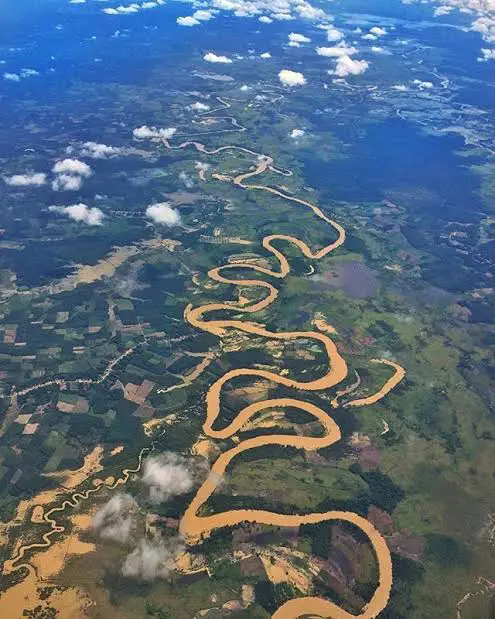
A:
[162,123,405,619]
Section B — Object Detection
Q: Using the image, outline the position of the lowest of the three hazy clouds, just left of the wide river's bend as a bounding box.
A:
[122,537,184,582]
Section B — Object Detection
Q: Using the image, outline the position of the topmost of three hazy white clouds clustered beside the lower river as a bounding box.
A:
[142,452,195,503]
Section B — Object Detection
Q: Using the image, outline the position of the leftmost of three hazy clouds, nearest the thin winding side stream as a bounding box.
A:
[91,492,137,543]
